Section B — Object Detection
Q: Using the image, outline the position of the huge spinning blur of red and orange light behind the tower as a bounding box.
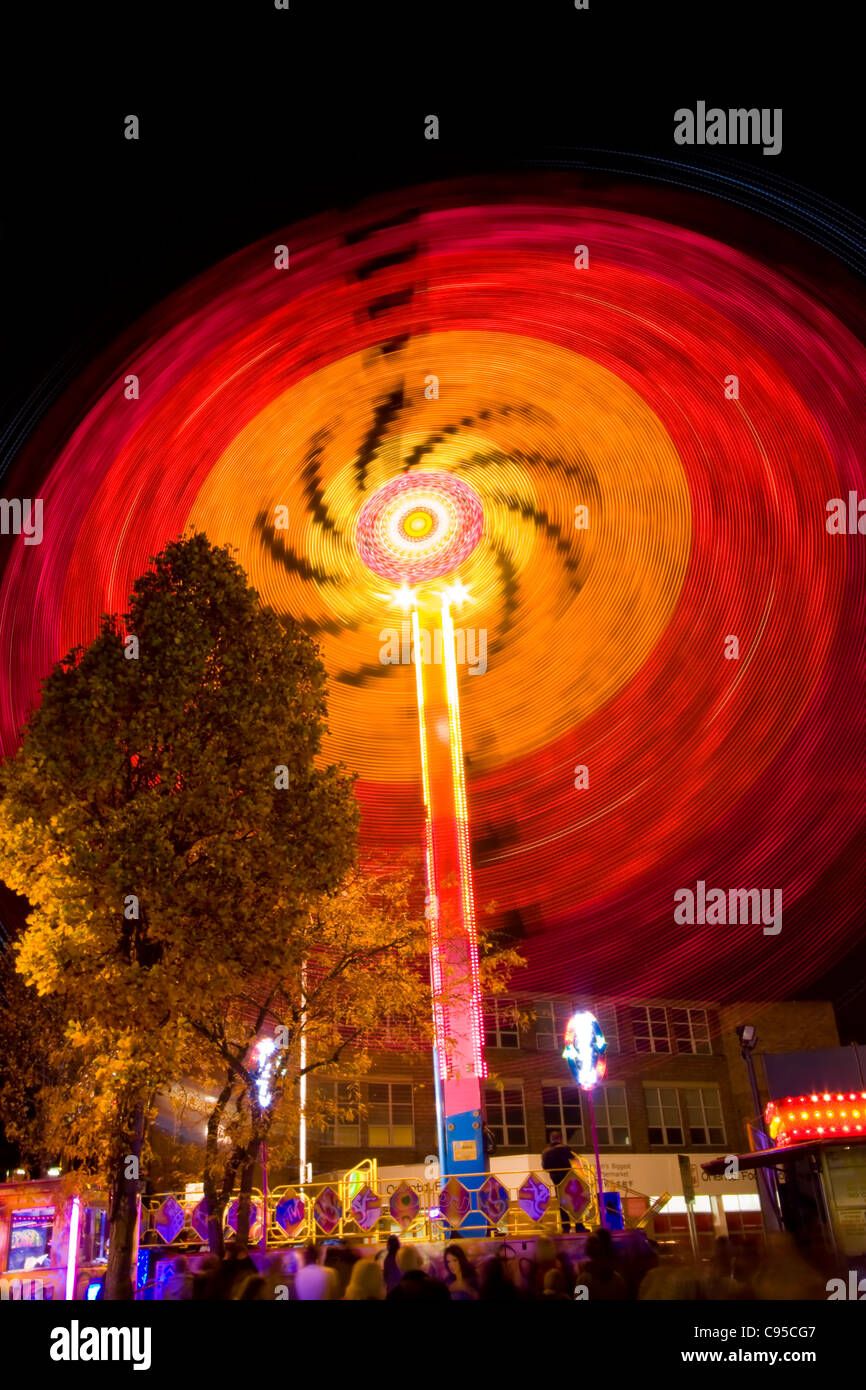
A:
[0,175,866,999]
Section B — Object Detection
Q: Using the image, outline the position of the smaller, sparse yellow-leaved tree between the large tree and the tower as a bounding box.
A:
[192,870,521,1254]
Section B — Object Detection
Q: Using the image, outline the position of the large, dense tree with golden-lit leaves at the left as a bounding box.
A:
[0,534,357,1297]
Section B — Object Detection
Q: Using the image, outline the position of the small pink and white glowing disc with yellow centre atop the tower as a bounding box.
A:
[357,473,484,584]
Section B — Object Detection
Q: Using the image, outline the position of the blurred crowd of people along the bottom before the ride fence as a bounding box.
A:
[155,1229,827,1302]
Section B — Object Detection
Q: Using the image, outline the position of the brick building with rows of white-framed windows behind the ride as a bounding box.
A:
[309,995,838,1244]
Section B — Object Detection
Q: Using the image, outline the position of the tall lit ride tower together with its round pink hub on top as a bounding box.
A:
[357,473,487,1195]
